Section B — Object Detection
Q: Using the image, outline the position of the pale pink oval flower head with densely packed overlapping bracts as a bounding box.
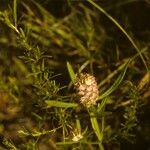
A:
[75,73,99,108]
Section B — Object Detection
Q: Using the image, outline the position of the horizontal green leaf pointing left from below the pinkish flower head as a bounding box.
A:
[45,100,78,108]
